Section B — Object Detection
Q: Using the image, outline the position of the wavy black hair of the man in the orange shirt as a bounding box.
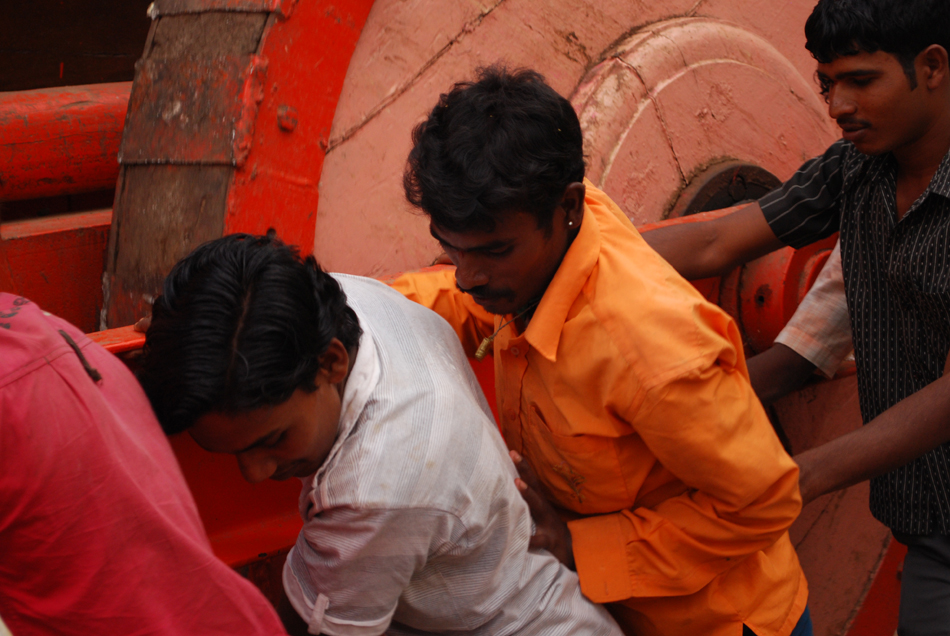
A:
[403,65,584,232]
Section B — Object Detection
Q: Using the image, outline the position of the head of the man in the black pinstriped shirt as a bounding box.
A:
[805,0,950,155]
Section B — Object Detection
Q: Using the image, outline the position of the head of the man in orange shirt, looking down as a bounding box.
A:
[404,67,584,314]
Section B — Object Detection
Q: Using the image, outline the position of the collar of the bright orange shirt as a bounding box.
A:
[524,191,600,362]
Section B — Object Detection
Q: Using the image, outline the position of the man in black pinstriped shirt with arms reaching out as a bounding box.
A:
[647,0,950,634]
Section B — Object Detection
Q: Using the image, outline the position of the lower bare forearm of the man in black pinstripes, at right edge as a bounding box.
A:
[795,375,950,503]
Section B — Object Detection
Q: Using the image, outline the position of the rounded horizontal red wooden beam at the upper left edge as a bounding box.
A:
[0,82,131,201]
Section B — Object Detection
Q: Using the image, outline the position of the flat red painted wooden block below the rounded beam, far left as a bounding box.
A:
[0,210,112,331]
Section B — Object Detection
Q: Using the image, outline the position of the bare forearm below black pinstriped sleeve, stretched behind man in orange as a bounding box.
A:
[643,203,784,280]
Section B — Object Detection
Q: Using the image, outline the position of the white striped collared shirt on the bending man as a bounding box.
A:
[284,275,620,636]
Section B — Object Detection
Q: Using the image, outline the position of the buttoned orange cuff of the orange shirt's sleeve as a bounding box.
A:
[567,514,633,603]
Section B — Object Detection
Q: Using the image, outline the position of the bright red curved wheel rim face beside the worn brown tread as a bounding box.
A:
[225,0,373,253]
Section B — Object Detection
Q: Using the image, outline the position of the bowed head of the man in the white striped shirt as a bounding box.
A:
[138,234,361,481]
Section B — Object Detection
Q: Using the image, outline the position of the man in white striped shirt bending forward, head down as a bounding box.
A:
[140,235,620,636]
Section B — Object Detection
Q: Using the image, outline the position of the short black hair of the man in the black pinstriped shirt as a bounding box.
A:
[805,0,950,89]
